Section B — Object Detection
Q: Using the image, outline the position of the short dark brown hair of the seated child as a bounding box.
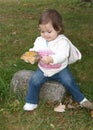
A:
[39,9,64,34]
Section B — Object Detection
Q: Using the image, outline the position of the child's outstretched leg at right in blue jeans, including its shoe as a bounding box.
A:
[52,67,93,109]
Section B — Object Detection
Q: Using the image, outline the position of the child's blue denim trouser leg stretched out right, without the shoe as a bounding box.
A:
[55,67,84,102]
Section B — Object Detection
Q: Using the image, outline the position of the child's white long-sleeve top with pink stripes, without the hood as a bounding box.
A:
[29,35,70,77]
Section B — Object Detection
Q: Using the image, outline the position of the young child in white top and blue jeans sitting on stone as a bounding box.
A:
[23,9,93,111]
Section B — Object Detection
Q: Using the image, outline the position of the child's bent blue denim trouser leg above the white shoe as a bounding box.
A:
[25,69,47,104]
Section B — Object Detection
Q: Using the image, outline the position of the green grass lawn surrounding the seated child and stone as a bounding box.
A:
[0,0,93,130]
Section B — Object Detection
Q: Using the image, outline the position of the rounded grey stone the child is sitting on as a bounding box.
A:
[10,70,66,102]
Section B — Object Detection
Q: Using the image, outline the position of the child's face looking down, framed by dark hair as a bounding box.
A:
[39,22,58,41]
